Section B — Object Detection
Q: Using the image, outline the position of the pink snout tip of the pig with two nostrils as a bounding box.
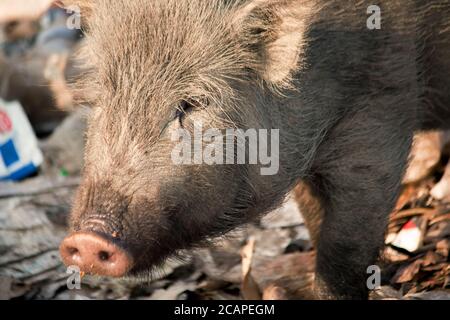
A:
[60,232,133,277]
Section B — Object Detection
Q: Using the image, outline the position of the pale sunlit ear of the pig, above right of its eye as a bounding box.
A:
[234,0,313,87]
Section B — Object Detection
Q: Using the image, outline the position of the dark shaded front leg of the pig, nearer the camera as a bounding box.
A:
[312,115,412,299]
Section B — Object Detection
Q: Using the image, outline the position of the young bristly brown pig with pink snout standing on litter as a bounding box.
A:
[60,0,450,299]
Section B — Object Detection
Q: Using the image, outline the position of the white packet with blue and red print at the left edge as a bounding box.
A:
[0,99,43,181]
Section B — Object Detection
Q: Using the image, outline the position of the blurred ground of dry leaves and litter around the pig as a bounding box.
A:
[0,0,450,300]
